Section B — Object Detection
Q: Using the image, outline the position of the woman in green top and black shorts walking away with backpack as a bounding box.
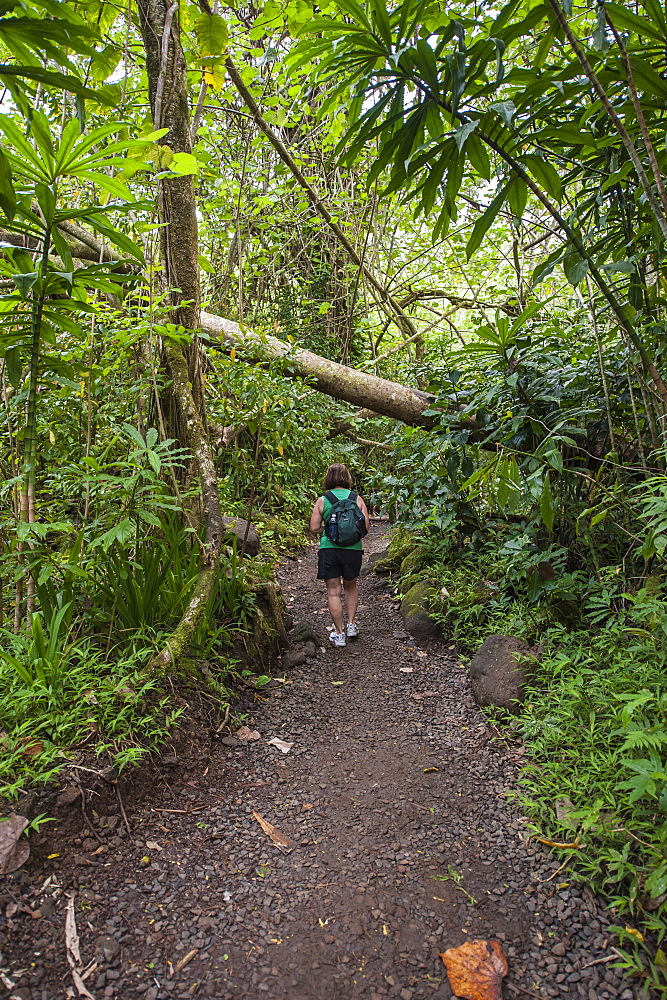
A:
[310,465,370,646]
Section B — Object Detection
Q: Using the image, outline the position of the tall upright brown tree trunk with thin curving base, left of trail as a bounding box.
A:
[137,0,224,668]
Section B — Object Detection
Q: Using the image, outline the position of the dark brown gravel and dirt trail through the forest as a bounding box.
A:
[0,528,633,1000]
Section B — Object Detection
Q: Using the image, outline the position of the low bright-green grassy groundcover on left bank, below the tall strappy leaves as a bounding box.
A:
[0,607,182,800]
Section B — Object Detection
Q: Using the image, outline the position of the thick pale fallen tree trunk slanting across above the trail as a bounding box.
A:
[200,312,434,427]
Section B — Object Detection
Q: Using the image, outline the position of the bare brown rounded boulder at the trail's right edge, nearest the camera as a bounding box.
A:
[470,635,534,713]
